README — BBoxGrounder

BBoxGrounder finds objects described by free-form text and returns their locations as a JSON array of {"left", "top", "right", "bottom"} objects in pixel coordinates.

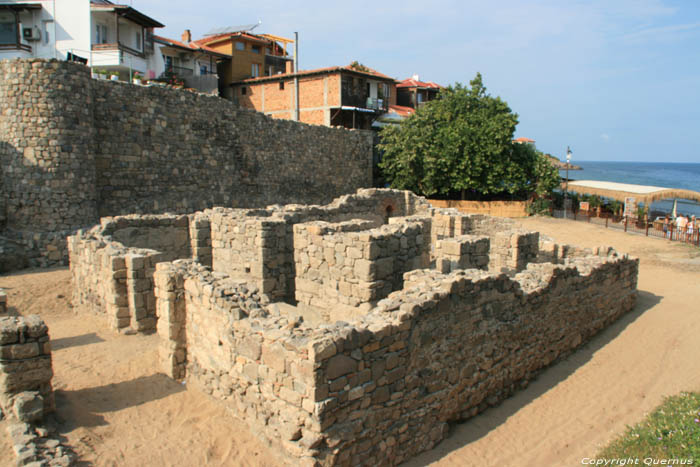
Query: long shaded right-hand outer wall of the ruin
[{"left": 304, "top": 257, "right": 638, "bottom": 465}]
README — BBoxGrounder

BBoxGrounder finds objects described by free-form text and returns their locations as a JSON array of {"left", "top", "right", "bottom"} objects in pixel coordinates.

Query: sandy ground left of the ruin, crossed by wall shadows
[{"left": 0, "top": 269, "right": 280, "bottom": 467}]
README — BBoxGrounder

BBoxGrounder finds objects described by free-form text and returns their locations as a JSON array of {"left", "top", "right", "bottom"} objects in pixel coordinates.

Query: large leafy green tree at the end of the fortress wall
[{"left": 380, "top": 73, "right": 558, "bottom": 199}]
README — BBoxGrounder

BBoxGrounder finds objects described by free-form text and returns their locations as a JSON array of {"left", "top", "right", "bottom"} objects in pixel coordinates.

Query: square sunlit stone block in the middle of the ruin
[{"left": 294, "top": 217, "right": 430, "bottom": 311}]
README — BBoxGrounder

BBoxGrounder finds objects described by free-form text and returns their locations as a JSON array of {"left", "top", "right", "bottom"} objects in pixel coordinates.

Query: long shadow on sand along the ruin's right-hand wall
[{"left": 401, "top": 290, "right": 663, "bottom": 467}]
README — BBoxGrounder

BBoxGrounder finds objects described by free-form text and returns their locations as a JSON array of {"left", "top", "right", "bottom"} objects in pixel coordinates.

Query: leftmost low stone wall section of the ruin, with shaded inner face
[{"left": 68, "top": 215, "right": 191, "bottom": 332}]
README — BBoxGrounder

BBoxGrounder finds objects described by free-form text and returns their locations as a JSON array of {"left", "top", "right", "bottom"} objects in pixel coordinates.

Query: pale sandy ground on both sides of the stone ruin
[{"left": 0, "top": 218, "right": 700, "bottom": 466}]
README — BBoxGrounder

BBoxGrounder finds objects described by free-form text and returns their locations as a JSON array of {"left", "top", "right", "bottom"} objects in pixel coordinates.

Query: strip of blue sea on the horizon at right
[{"left": 559, "top": 161, "right": 700, "bottom": 217}]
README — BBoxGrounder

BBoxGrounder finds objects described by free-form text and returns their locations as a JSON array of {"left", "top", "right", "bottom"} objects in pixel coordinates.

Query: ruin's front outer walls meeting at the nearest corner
[{"left": 155, "top": 241, "right": 638, "bottom": 465}]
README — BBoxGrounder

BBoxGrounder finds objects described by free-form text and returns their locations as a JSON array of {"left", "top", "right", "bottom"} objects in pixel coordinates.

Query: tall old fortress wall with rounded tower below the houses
[{"left": 0, "top": 59, "right": 372, "bottom": 264}]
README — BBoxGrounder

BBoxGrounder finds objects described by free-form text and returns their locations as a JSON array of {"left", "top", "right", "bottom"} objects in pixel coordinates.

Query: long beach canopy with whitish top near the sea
[{"left": 561, "top": 180, "right": 700, "bottom": 204}]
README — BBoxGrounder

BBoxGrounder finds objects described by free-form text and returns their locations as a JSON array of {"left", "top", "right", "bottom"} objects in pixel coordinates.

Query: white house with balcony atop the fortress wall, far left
[{"left": 0, "top": 0, "right": 163, "bottom": 75}]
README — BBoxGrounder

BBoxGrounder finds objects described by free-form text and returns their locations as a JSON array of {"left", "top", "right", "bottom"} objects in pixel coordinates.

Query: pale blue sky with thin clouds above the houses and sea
[{"left": 133, "top": 0, "right": 700, "bottom": 163}]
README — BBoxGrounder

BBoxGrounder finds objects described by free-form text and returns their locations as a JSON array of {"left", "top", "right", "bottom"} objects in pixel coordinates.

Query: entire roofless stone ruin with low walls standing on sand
[{"left": 69, "top": 189, "right": 638, "bottom": 465}]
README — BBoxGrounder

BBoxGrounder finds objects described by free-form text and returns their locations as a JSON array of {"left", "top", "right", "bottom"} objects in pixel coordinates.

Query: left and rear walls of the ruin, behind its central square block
[{"left": 67, "top": 189, "right": 429, "bottom": 332}]
